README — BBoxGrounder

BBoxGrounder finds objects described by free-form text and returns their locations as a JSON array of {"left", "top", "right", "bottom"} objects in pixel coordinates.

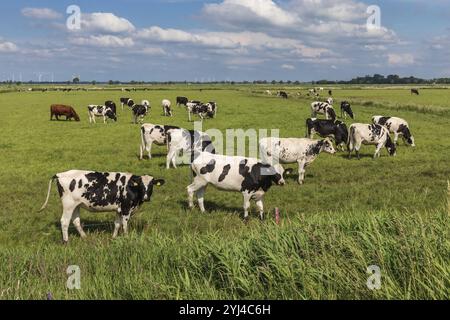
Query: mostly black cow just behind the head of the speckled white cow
[{"left": 306, "top": 118, "right": 348, "bottom": 150}]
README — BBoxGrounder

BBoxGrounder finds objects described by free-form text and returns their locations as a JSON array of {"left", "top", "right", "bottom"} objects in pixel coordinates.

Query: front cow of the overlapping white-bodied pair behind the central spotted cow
[{"left": 166, "top": 129, "right": 216, "bottom": 169}]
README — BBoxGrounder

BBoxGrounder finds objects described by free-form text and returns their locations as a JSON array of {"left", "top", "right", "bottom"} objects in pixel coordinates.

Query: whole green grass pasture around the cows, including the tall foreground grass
[{"left": 0, "top": 86, "right": 450, "bottom": 299}]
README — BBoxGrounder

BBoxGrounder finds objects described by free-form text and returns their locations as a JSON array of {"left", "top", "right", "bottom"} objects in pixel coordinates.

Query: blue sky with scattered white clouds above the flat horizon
[{"left": 0, "top": 0, "right": 450, "bottom": 81}]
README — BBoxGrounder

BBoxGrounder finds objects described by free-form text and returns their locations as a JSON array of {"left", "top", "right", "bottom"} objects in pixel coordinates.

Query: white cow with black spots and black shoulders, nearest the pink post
[{"left": 187, "top": 152, "right": 285, "bottom": 220}]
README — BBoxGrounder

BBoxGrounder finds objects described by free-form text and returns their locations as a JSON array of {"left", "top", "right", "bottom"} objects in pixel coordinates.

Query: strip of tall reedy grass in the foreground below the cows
[{"left": 0, "top": 207, "right": 450, "bottom": 299}]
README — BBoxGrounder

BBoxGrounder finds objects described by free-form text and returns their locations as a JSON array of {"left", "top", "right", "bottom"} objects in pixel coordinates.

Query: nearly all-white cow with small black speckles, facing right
[{"left": 259, "top": 138, "right": 336, "bottom": 184}]
